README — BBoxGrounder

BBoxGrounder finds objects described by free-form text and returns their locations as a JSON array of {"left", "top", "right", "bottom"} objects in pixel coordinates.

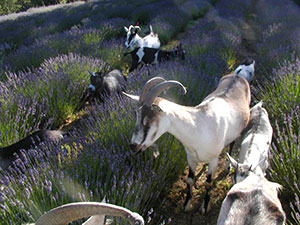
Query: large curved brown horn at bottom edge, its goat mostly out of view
[{"left": 35, "top": 202, "right": 144, "bottom": 225}]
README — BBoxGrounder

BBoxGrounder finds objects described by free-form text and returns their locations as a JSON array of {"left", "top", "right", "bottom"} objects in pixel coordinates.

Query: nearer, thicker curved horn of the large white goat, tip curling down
[{"left": 144, "top": 80, "right": 186, "bottom": 106}]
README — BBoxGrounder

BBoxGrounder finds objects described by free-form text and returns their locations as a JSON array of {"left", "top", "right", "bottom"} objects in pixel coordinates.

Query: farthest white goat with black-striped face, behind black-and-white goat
[{"left": 124, "top": 25, "right": 160, "bottom": 50}]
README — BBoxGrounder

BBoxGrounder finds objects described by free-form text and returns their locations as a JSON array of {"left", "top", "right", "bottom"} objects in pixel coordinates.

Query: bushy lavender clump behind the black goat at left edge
[{"left": 0, "top": 54, "right": 107, "bottom": 145}]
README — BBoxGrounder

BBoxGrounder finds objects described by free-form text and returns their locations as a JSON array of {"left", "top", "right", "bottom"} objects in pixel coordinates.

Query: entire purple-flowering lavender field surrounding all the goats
[{"left": 0, "top": 0, "right": 300, "bottom": 225}]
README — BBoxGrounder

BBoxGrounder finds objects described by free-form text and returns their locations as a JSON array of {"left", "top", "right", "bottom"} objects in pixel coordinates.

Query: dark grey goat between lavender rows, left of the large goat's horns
[{"left": 89, "top": 69, "right": 127, "bottom": 102}]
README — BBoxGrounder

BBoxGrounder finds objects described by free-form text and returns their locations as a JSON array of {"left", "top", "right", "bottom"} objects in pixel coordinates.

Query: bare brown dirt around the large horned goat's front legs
[{"left": 161, "top": 153, "right": 231, "bottom": 225}]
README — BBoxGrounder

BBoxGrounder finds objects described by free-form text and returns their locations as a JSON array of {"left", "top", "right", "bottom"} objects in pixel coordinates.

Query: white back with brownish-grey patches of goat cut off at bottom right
[{"left": 217, "top": 168, "right": 286, "bottom": 225}]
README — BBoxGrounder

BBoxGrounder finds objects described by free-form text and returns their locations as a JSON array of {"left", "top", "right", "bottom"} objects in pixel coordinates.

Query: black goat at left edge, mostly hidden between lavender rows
[{"left": 0, "top": 130, "right": 64, "bottom": 170}]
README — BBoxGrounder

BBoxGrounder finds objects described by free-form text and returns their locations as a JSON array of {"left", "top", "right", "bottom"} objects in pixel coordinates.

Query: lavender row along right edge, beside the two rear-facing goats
[{"left": 254, "top": 55, "right": 300, "bottom": 224}]
